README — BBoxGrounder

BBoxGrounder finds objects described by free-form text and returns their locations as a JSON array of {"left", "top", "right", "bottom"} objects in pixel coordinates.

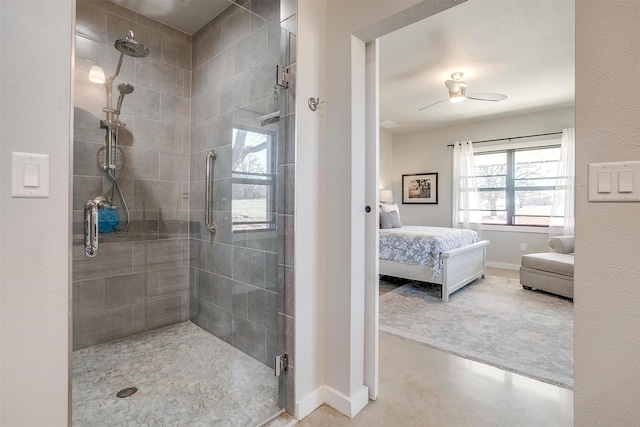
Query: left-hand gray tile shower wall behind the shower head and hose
[{"left": 73, "top": 0, "right": 192, "bottom": 349}]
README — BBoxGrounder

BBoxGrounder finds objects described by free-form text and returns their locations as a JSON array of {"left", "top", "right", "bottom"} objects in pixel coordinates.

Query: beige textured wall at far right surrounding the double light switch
[{"left": 574, "top": 1, "right": 640, "bottom": 426}]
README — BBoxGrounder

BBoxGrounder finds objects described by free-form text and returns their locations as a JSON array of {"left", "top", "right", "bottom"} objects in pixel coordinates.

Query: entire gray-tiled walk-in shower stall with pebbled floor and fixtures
[{"left": 72, "top": 0, "right": 295, "bottom": 426}]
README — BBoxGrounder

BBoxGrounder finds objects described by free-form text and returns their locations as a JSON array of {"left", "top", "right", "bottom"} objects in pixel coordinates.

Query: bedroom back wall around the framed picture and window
[{"left": 392, "top": 108, "right": 580, "bottom": 269}]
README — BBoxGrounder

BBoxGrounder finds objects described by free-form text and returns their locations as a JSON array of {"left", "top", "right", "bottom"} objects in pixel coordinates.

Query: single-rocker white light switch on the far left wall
[{"left": 11, "top": 152, "right": 49, "bottom": 197}]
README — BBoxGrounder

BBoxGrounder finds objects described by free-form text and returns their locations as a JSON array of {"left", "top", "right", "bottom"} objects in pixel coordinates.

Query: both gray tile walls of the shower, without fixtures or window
[{"left": 73, "top": 0, "right": 297, "bottom": 413}]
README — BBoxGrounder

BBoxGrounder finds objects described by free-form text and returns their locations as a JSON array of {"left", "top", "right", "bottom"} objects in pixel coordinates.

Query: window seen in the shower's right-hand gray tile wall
[{"left": 231, "top": 127, "right": 276, "bottom": 232}]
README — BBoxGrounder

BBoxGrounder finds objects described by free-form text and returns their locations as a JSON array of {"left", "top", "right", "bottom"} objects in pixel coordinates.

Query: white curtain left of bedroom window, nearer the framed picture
[{"left": 452, "top": 141, "right": 480, "bottom": 229}]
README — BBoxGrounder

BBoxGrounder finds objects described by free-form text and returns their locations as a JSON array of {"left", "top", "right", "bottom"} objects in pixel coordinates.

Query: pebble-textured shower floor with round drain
[{"left": 73, "top": 322, "right": 280, "bottom": 427}]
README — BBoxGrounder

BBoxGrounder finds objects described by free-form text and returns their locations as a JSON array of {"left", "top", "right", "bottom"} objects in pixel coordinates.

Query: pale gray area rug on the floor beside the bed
[{"left": 380, "top": 276, "right": 573, "bottom": 389}]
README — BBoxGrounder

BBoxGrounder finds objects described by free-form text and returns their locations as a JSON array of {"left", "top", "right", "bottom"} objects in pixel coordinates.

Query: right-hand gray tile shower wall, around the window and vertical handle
[{"left": 185, "top": 1, "right": 296, "bottom": 413}]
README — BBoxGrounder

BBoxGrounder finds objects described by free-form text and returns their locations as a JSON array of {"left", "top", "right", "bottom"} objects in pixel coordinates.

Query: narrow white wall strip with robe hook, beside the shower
[{"left": 294, "top": 0, "right": 327, "bottom": 417}]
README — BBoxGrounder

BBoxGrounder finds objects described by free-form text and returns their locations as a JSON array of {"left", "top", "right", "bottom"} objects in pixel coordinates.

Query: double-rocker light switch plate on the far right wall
[{"left": 589, "top": 161, "right": 640, "bottom": 202}]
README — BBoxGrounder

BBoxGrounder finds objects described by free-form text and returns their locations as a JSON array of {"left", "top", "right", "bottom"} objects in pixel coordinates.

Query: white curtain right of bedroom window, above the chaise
[{"left": 549, "top": 128, "right": 576, "bottom": 237}]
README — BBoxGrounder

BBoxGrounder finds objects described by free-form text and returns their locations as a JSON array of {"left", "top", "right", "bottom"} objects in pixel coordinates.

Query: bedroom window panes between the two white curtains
[{"left": 474, "top": 145, "right": 560, "bottom": 226}]
